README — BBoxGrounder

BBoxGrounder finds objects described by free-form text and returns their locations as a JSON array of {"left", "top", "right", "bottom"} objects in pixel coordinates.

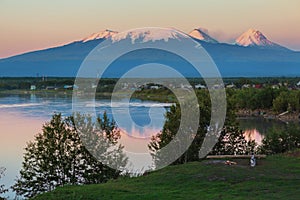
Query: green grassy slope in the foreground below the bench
[{"left": 34, "top": 152, "right": 300, "bottom": 200}]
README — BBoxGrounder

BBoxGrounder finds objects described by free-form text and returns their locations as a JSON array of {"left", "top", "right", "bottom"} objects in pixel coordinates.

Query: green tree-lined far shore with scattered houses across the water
[{"left": 0, "top": 77, "right": 300, "bottom": 123}]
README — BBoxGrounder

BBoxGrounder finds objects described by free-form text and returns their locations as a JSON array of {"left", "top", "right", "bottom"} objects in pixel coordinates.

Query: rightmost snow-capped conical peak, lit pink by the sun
[{"left": 235, "top": 28, "right": 284, "bottom": 48}]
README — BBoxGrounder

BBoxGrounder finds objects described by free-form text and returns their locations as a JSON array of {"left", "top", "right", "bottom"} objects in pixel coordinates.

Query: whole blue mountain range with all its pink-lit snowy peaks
[{"left": 0, "top": 28, "right": 300, "bottom": 77}]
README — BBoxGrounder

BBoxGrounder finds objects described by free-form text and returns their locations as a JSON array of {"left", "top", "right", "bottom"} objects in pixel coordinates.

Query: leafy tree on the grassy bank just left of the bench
[{"left": 148, "top": 90, "right": 256, "bottom": 164}]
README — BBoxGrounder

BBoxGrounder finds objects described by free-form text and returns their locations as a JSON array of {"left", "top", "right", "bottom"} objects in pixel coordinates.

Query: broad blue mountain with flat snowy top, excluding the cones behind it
[{"left": 0, "top": 29, "right": 300, "bottom": 77}]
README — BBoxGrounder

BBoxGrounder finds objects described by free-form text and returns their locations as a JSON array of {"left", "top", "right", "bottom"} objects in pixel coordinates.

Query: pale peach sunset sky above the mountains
[{"left": 0, "top": 0, "right": 300, "bottom": 58}]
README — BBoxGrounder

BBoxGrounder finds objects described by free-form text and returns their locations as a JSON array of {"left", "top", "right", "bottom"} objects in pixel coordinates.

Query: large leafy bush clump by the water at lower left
[{"left": 12, "top": 113, "right": 127, "bottom": 198}]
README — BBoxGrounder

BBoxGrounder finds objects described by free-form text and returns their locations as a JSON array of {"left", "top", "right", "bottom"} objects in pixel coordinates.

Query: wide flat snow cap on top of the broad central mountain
[{"left": 111, "top": 28, "right": 188, "bottom": 43}]
